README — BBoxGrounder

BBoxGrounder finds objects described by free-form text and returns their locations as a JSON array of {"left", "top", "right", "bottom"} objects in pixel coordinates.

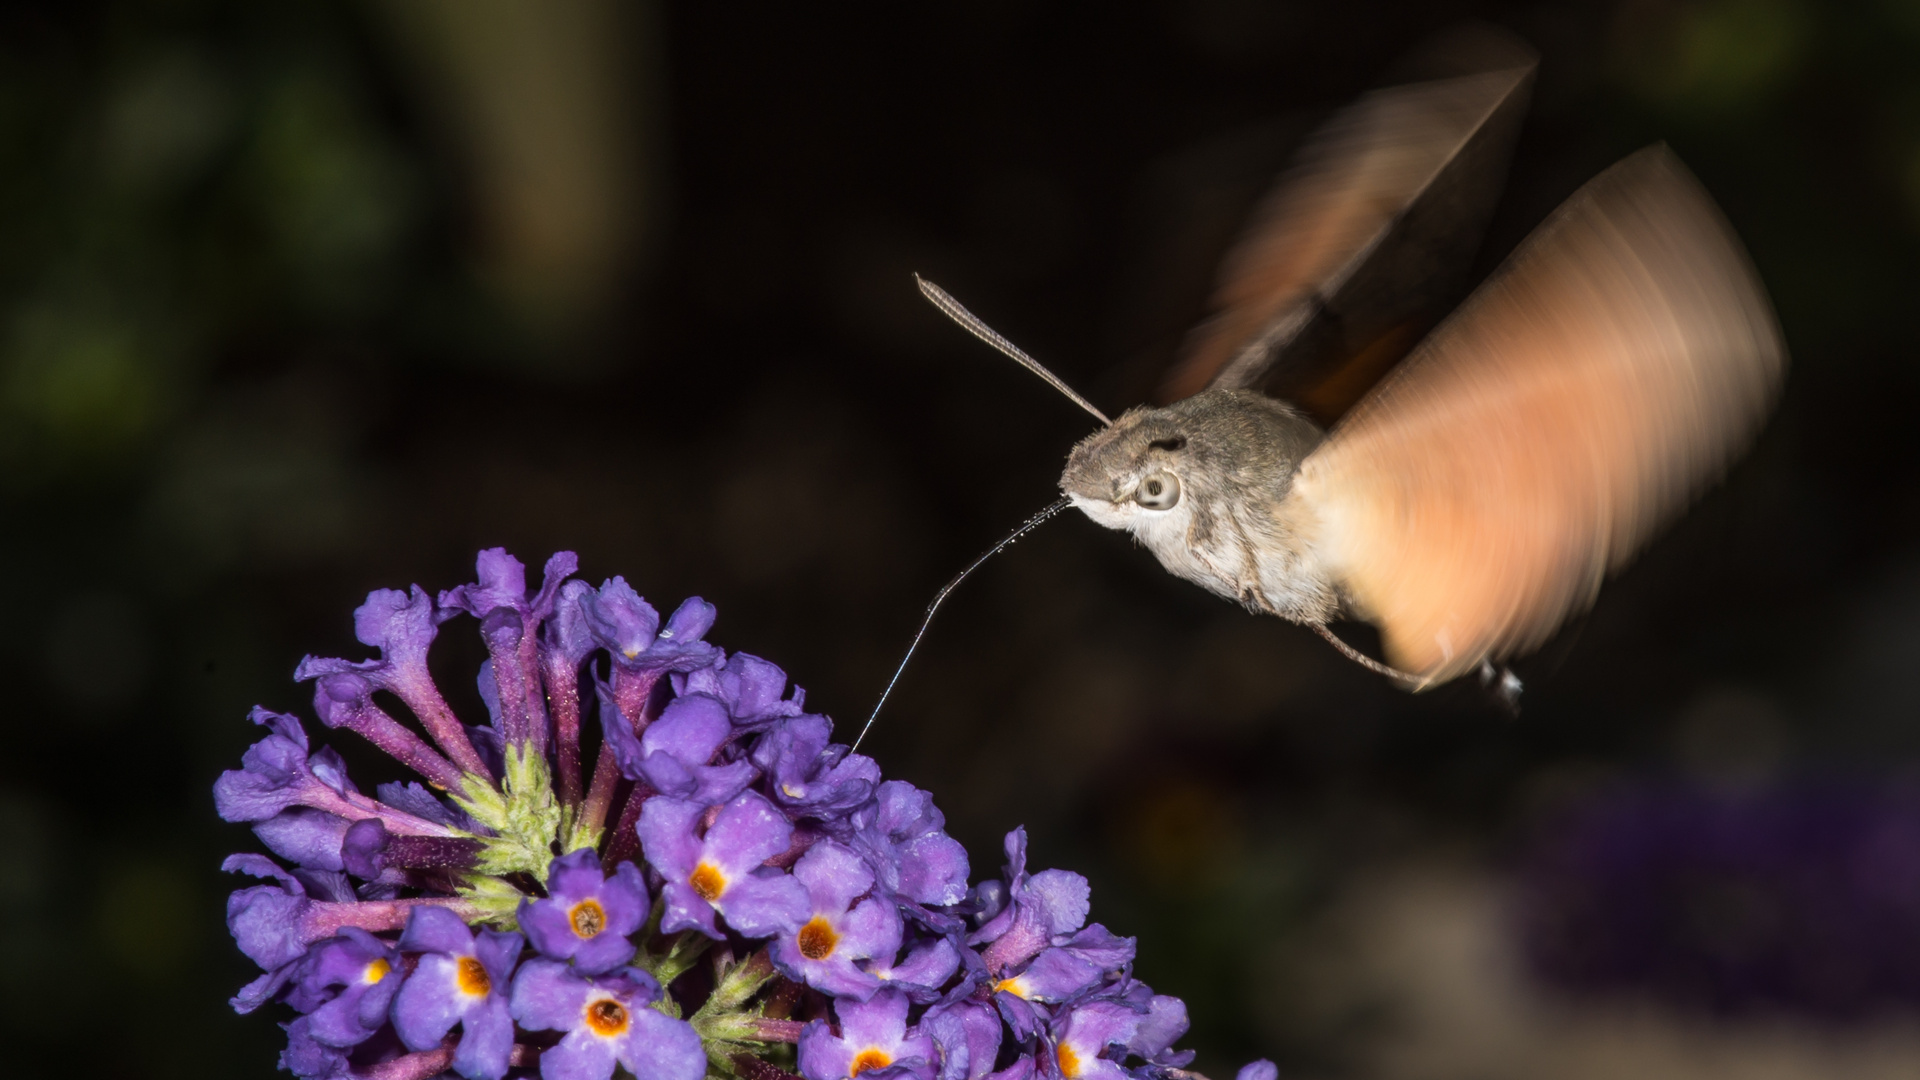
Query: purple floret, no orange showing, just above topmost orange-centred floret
[{"left": 601, "top": 694, "right": 758, "bottom": 805}]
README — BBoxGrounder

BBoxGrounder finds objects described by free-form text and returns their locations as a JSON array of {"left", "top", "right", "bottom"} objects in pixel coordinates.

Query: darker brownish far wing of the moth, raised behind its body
[{"left": 1158, "top": 38, "right": 1534, "bottom": 421}]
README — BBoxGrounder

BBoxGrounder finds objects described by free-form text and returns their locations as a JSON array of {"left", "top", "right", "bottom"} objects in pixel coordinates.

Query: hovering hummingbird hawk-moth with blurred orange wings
[{"left": 864, "top": 27, "right": 1786, "bottom": 737}]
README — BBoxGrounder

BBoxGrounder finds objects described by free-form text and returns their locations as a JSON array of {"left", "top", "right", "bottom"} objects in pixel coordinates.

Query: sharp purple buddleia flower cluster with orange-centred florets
[{"left": 215, "top": 550, "right": 1273, "bottom": 1080}]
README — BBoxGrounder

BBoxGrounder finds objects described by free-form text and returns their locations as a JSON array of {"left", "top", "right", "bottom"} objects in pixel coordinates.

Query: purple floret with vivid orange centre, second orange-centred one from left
[{"left": 394, "top": 907, "right": 520, "bottom": 1080}]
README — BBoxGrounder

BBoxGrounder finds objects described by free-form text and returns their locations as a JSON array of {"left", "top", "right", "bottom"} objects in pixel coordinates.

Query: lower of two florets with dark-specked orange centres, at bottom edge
[{"left": 513, "top": 959, "right": 707, "bottom": 1080}]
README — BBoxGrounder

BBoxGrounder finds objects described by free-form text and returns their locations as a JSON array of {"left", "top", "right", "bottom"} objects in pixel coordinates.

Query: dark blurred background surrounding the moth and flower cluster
[{"left": 0, "top": 0, "right": 1920, "bottom": 1080}]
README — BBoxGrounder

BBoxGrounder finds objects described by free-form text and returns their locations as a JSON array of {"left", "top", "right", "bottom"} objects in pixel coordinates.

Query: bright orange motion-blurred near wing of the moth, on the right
[{"left": 1294, "top": 146, "right": 1786, "bottom": 682}]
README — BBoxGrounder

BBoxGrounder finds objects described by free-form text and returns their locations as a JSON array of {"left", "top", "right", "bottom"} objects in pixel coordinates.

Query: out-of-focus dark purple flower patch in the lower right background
[{"left": 1515, "top": 776, "right": 1920, "bottom": 1019}]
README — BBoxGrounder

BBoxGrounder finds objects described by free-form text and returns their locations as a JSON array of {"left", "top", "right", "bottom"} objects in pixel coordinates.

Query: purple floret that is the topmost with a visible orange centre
[{"left": 639, "top": 792, "right": 810, "bottom": 938}]
